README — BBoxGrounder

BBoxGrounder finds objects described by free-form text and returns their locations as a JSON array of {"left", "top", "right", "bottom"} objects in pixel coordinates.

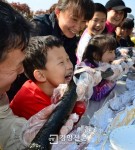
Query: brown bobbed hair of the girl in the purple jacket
[{"left": 82, "top": 34, "right": 116, "bottom": 61}]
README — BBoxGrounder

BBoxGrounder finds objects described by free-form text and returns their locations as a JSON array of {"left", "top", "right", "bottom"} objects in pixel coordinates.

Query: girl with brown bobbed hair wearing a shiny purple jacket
[{"left": 82, "top": 35, "right": 116, "bottom": 101}]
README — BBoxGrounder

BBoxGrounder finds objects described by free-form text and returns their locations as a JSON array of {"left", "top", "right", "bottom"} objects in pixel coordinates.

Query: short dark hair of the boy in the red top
[{"left": 23, "top": 35, "right": 63, "bottom": 81}]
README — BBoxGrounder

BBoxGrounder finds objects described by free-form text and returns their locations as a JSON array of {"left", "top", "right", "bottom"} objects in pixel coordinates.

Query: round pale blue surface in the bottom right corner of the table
[{"left": 109, "top": 125, "right": 135, "bottom": 150}]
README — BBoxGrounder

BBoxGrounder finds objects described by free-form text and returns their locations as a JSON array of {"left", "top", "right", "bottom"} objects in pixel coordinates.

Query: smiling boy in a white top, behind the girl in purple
[{"left": 76, "top": 3, "right": 107, "bottom": 63}]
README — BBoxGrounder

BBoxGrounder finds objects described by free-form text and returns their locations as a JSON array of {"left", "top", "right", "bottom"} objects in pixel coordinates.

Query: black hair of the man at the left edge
[{"left": 0, "top": 1, "right": 31, "bottom": 62}]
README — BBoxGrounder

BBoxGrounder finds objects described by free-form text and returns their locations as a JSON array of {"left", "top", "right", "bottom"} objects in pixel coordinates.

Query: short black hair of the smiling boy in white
[{"left": 94, "top": 3, "right": 107, "bottom": 18}]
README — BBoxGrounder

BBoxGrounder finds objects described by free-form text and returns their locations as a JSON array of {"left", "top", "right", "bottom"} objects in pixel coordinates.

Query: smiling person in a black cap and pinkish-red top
[{"left": 104, "top": 0, "right": 131, "bottom": 33}]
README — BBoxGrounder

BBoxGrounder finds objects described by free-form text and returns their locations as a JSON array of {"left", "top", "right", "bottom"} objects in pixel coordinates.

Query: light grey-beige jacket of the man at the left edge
[{"left": 0, "top": 94, "right": 27, "bottom": 150}]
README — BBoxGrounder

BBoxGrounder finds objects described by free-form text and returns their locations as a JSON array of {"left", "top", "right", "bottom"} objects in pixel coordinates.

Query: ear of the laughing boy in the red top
[{"left": 33, "top": 70, "right": 46, "bottom": 82}]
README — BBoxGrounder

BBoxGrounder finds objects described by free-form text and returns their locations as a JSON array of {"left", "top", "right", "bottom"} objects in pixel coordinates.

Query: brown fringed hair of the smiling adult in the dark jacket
[{"left": 56, "top": 0, "right": 94, "bottom": 20}]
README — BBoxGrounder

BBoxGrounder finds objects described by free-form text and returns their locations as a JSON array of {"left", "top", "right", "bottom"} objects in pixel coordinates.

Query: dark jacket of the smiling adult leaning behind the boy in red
[{"left": 32, "top": 13, "right": 79, "bottom": 66}]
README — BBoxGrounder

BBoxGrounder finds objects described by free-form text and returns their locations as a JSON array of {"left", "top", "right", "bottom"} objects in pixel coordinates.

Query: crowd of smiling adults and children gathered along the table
[{"left": 0, "top": 0, "right": 135, "bottom": 150}]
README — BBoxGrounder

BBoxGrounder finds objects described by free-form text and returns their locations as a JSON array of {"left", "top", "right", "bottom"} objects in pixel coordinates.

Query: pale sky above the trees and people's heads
[{"left": 7, "top": 0, "right": 135, "bottom": 17}]
